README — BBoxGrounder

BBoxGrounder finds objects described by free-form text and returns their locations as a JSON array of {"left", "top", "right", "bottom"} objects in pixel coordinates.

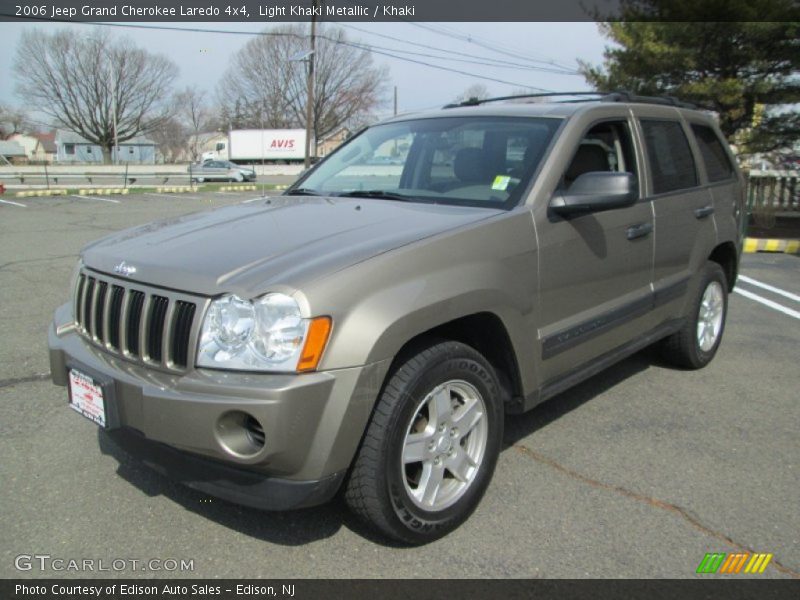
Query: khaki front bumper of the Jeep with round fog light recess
[{"left": 48, "top": 304, "right": 389, "bottom": 510}]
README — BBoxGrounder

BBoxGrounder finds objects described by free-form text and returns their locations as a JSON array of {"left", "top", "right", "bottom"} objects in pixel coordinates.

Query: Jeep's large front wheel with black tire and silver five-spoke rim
[{"left": 345, "top": 342, "right": 503, "bottom": 544}]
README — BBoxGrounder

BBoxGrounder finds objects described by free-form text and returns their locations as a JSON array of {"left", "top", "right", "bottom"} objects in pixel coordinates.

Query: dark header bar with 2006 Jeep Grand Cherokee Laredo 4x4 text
[{"left": 6, "top": 0, "right": 800, "bottom": 22}]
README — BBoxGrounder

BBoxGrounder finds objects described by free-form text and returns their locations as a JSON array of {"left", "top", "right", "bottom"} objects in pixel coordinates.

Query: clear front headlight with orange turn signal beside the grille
[{"left": 197, "top": 294, "right": 330, "bottom": 372}]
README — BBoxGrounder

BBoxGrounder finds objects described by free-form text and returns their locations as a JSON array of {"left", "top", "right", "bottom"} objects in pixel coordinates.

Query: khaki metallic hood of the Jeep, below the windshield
[{"left": 82, "top": 196, "right": 494, "bottom": 297}]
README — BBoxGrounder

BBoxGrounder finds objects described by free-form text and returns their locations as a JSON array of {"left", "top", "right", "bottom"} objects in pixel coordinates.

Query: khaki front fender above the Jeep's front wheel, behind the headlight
[{"left": 302, "top": 209, "right": 537, "bottom": 396}]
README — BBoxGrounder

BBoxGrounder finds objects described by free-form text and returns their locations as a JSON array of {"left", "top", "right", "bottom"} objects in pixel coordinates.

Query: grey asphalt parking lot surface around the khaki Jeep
[{"left": 0, "top": 192, "right": 800, "bottom": 578}]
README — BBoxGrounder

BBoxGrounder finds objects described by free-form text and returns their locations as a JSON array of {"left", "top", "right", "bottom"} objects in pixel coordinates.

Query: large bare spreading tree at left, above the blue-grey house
[{"left": 14, "top": 30, "right": 178, "bottom": 163}]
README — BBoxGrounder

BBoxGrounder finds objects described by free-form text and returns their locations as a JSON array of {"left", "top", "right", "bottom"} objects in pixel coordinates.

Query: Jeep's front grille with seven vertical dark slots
[{"left": 74, "top": 269, "right": 205, "bottom": 371}]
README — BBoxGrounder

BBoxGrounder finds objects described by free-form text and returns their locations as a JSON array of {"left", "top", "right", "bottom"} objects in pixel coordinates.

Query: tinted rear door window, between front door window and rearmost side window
[{"left": 641, "top": 119, "right": 698, "bottom": 194}]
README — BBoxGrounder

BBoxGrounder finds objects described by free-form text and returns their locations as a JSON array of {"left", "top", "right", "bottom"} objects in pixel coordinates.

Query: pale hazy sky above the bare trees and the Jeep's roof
[{"left": 0, "top": 22, "right": 607, "bottom": 123}]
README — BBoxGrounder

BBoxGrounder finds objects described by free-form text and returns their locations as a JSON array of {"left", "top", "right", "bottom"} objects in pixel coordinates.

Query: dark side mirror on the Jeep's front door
[{"left": 550, "top": 171, "right": 639, "bottom": 217}]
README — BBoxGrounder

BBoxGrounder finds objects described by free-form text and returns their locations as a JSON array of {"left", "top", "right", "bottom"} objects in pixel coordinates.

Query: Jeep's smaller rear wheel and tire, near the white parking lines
[{"left": 662, "top": 261, "right": 728, "bottom": 369}]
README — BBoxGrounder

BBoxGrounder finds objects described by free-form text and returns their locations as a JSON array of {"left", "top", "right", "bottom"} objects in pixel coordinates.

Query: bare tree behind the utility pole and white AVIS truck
[{"left": 217, "top": 24, "right": 386, "bottom": 145}]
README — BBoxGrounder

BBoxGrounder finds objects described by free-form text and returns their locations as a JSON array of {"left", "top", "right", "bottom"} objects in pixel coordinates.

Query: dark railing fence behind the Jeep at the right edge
[{"left": 747, "top": 171, "right": 800, "bottom": 228}]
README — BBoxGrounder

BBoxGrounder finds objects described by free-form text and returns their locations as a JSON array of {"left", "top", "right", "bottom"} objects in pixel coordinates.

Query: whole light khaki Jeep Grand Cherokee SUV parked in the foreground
[{"left": 49, "top": 95, "right": 743, "bottom": 543}]
